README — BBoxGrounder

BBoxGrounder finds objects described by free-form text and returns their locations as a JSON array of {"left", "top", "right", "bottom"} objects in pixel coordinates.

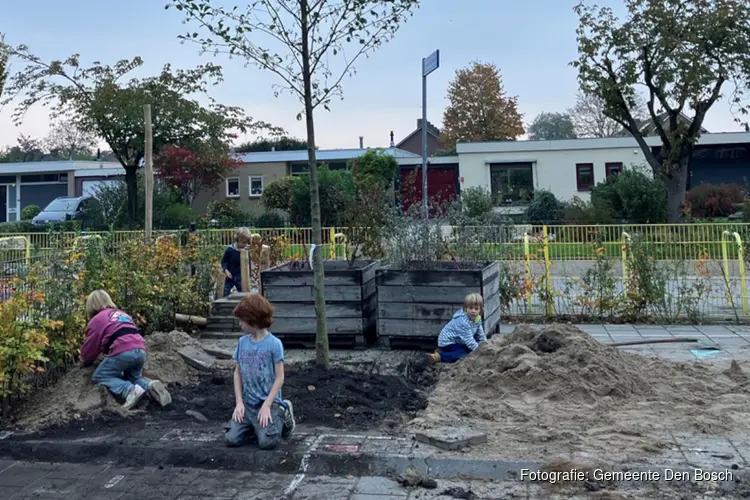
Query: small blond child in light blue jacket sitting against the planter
[{"left": 427, "top": 293, "right": 487, "bottom": 363}]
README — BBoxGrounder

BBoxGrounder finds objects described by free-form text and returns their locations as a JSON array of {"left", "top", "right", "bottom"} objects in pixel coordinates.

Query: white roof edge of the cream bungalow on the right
[{"left": 456, "top": 132, "right": 750, "bottom": 154}]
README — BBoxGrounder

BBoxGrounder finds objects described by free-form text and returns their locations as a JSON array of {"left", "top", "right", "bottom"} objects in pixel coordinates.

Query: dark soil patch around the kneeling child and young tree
[{"left": 27, "top": 358, "right": 439, "bottom": 435}]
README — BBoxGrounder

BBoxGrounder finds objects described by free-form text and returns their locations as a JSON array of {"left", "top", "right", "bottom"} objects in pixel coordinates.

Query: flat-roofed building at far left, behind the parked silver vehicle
[{"left": 0, "top": 161, "right": 125, "bottom": 222}]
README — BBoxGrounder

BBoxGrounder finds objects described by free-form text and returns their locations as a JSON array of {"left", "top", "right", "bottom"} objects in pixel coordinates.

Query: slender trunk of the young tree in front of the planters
[{"left": 300, "top": 0, "right": 330, "bottom": 370}]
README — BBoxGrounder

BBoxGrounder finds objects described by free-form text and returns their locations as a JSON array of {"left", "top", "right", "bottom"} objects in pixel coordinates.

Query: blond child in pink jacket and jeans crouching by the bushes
[{"left": 81, "top": 290, "right": 172, "bottom": 410}]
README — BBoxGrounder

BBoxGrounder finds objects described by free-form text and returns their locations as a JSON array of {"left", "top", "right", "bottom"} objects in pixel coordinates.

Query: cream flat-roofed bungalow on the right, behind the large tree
[{"left": 456, "top": 132, "right": 750, "bottom": 213}]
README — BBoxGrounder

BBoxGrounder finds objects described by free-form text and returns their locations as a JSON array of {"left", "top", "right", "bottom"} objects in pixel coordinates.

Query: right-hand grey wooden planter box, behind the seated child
[{"left": 376, "top": 262, "right": 500, "bottom": 348}]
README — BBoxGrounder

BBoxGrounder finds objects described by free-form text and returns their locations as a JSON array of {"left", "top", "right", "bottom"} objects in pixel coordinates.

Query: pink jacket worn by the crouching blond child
[{"left": 81, "top": 309, "right": 146, "bottom": 366}]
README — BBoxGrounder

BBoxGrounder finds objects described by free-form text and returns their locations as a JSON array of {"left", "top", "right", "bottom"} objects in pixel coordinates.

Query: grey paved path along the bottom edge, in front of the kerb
[{"left": 0, "top": 461, "right": 745, "bottom": 500}]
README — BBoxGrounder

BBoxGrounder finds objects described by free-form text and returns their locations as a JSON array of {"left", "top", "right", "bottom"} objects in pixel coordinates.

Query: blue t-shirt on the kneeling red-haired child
[{"left": 232, "top": 332, "right": 284, "bottom": 407}]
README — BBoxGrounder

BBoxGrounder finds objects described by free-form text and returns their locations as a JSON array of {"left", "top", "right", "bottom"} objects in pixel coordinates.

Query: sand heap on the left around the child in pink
[{"left": 16, "top": 330, "right": 220, "bottom": 432}]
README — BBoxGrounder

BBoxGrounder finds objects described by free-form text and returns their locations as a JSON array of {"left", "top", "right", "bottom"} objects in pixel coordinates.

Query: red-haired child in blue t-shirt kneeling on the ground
[{"left": 225, "top": 293, "right": 295, "bottom": 450}]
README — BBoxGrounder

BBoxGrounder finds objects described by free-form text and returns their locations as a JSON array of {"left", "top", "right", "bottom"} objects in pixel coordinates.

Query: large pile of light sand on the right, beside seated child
[{"left": 412, "top": 325, "right": 750, "bottom": 459}]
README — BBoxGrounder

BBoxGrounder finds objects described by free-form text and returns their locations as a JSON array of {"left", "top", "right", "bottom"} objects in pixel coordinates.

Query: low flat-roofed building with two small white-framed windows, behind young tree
[{"left": 193, "top": 147, "right": 421, "bottom": 213}]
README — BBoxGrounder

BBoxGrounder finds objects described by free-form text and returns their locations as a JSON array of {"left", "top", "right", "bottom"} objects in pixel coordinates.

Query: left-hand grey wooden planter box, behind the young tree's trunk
[{"left": 260, "top": 260, "right": 377, "bottom": 348}]
